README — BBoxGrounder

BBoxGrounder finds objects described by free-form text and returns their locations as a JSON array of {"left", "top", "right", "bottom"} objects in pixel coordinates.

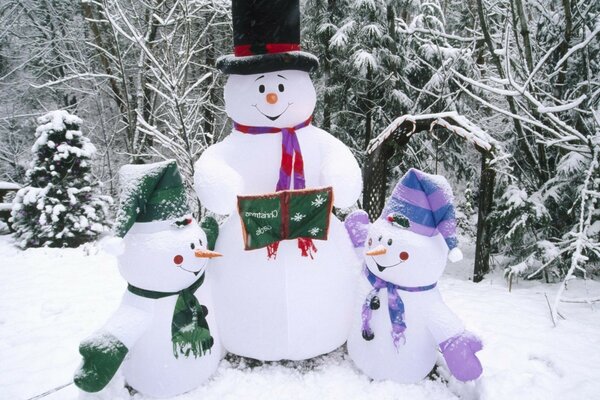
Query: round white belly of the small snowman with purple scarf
[{"left": 348, "top": 282, "right": 437, "bottom": 383}]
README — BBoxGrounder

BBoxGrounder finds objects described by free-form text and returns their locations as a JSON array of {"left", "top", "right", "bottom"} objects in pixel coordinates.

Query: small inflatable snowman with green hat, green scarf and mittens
[{"left": 74, "top": 161, "right": 223, "bottom": 397}]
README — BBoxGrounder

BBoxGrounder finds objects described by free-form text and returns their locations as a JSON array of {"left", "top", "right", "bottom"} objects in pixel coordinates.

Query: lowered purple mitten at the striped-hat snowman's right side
[{"left": 440, "top": 331, "right": 483, "bottom": 382}]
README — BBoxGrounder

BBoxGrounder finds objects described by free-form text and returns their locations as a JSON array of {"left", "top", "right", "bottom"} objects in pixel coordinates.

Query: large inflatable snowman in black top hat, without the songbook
[{"left": 195, "top": 0, "right": 362, "bottom": 360}]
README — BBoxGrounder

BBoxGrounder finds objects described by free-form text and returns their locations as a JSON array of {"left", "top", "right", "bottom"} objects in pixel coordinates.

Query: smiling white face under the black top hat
[{"left": 225, "top": 70, "right": 317, "bottom": 128}]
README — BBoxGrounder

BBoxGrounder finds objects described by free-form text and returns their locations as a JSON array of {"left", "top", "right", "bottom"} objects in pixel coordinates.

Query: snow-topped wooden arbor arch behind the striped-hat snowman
[{"left": 363, "top": 111, "right": 501, "bottom": 282}]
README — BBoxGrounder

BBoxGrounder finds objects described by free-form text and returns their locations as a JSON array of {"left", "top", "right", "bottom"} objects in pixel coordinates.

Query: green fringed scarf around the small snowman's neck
[{"left": 127, "top": 274, "right": 214, "bottom": 358}]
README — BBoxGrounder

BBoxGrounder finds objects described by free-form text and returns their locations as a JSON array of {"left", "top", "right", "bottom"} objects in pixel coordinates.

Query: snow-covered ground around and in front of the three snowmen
[{"left": 0, "top": 236, "right": 600, "bottom": 400}]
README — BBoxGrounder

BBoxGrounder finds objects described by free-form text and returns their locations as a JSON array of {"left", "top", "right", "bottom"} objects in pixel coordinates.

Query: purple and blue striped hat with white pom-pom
[{"left": 379, "top": 168, "right": 462, "bottom": 261}]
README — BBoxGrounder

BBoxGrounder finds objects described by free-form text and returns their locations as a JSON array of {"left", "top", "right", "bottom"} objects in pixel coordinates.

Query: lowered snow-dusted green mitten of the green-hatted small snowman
[{"left": 73, "top": 332, "right": 129, "bottom": 393}]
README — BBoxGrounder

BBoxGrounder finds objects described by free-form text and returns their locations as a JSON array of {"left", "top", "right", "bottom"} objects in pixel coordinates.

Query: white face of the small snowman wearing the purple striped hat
[{"left": 365, "top": 219, "right": 448, "bottom": 287}]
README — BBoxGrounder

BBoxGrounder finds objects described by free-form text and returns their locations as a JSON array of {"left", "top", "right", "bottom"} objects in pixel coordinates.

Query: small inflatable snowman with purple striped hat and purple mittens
[{"left": 345, "top": 169, "right": 482, "bottom": 383}]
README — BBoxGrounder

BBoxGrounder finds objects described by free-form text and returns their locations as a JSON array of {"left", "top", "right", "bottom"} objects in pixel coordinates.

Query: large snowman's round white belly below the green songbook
[{"left": 209, "top": 216, "right": 359, "bottom": 360}]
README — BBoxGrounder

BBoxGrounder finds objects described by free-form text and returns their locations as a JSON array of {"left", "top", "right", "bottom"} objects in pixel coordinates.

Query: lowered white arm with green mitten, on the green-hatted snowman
[{"left": 73, "top": 304, "right": 151, "bottom": 393}]
